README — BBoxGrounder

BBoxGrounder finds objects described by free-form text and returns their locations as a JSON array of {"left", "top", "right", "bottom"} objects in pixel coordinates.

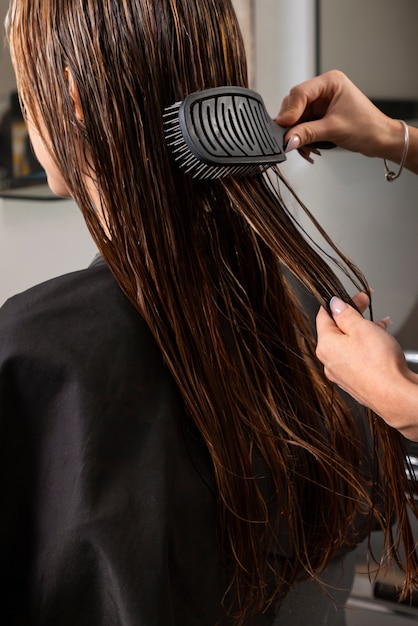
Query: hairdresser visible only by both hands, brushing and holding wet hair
[{"left": 277, "top": 71, "right": 418, "bottom": 441}]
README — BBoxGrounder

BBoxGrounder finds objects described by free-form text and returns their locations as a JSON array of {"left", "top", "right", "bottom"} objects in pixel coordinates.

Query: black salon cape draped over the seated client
[{"left": 0, "top": 256, "right": 353, "bottom": 626}]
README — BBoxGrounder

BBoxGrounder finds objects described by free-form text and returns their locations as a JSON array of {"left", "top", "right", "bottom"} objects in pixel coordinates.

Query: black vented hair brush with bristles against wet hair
[{"left": 163, "top": 87, "right": 334, "bottom": 179}]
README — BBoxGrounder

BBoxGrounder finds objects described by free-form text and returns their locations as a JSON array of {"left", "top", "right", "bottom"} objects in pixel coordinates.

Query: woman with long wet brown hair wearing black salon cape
[{"left": 0, "top": 6, "right": 418, "bottom": 626}]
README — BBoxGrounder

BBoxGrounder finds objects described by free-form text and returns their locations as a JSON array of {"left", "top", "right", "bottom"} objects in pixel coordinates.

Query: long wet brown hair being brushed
[{"left": 9, "top": 0, "right": 418, "bottom": 623}]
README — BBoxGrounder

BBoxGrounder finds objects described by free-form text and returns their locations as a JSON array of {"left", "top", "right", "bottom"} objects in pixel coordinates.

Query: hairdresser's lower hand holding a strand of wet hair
[{"left": 317, "top": 293, "right": 418, "bottom": 440}]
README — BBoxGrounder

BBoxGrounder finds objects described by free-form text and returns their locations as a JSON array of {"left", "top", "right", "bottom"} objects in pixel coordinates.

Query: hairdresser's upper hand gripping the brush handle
[{"left": 276, "top": 70, "right": 404, "bottom": 162}]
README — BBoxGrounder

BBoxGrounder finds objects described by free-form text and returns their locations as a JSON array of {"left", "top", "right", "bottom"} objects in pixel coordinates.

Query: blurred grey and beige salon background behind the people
[{"left": 0, "top": 0, "right": 418, "bottom": 626}]
